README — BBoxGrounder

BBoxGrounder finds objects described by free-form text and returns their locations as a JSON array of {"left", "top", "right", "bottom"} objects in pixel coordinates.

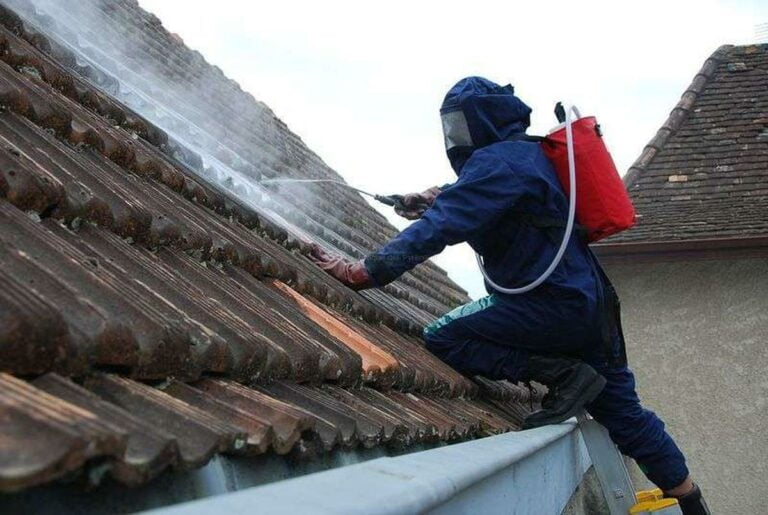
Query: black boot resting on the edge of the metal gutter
[{"left": 523, "top": 356, "right": 605, "bottom": 429}]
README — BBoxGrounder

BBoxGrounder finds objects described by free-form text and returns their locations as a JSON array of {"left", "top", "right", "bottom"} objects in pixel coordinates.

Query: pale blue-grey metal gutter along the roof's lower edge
[{"left": 146, "top": 422, "right": 590, "bottom": 515}]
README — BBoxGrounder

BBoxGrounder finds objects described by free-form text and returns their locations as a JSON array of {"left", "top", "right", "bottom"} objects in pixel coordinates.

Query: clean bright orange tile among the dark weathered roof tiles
[{"left": 272, "top": 280, "right": 400, "bottom": 378}]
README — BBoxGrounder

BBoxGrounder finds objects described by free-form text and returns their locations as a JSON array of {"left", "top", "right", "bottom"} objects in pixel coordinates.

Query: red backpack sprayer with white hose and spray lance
[{"left": 261, "top": 103, "right": 635, "bottom": 294}]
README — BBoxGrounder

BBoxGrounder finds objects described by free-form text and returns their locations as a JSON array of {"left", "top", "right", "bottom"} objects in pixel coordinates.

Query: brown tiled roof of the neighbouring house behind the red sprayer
[{"left": 603, "top": 45, "right": 768, "bottom": 246}]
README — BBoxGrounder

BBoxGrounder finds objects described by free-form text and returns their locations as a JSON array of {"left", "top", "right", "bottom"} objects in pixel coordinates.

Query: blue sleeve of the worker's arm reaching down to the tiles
[{"left": 364, "top": 150, "right": 521, "bottom": 286}]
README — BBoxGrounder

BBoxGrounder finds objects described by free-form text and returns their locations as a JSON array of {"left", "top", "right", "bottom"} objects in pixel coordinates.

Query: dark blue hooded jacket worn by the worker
[{"left": 365, "top": 77, "right": 601, "bottom": 332}]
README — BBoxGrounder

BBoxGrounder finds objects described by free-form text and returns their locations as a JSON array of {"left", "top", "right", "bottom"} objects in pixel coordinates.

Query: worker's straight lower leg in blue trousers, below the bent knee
[{"left": 587, "top": 362, "right": 688, "bottom": 491}]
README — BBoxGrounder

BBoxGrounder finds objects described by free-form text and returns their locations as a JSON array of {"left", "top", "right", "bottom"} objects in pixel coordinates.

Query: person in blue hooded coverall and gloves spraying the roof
[{"left": 312, "top": 77, "right": 709, "bottom": 515}]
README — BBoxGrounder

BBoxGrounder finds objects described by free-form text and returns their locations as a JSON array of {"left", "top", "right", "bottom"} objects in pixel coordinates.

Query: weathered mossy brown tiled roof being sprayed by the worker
[{"left": 0, "top": 0, "right": 529, "bottom": 491}]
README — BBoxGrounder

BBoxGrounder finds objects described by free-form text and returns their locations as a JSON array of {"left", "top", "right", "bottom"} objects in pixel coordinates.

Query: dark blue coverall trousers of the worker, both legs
[{"left": 424, "top": 295, "right": 688, "bottom": 490}]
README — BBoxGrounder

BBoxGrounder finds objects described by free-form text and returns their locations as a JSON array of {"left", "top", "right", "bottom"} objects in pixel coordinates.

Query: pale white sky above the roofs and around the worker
[{"left": 139, "top": 0, "right": 768, "bottom": 298}]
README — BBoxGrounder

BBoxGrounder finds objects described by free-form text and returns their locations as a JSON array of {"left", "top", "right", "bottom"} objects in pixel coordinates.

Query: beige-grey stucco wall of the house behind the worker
[{"left": 606, "top": 259, "right": 768, "bottom": 514}]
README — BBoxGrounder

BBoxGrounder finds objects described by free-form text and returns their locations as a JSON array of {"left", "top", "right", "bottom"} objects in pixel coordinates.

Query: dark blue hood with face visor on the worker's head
[{"left": 440, "top": 77, "right": 531, "bottom": 175}]
